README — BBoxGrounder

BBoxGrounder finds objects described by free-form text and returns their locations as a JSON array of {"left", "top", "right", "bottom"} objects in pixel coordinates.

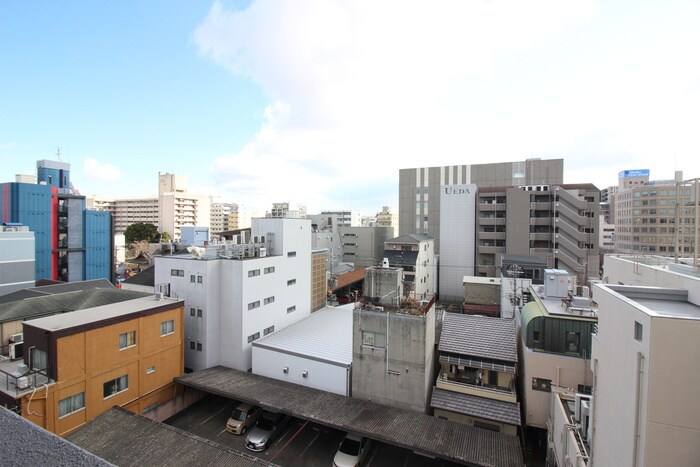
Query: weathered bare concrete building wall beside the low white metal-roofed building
[{"left": 352, "top": 309, "right": 435, "bottom": 412}]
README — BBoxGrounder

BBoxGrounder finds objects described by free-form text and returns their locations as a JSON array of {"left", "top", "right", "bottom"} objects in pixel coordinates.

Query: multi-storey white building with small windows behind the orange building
[{"left": 155, "top": 218, "right": 311, "bottom": 371}]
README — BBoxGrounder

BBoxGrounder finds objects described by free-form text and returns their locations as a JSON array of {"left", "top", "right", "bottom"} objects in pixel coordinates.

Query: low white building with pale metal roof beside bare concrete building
[{"left": 253, "top": 303, "right": 355, "bottom": 396}]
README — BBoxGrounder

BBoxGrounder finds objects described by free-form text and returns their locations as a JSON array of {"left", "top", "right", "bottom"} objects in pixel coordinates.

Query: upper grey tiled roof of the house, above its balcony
[{"left": 438, "top": 312, "right": 518, "bottom": 362}]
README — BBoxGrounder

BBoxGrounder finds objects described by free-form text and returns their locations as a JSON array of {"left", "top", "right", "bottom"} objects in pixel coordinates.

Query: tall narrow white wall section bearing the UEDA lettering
[{"left": 438, "top": 185, "right": 476, "bottom": 303}]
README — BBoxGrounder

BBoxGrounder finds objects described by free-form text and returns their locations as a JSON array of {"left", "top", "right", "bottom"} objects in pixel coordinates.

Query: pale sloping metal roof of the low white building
[{"left": 253, "top": 303, "right": 355, "bottom": 367}]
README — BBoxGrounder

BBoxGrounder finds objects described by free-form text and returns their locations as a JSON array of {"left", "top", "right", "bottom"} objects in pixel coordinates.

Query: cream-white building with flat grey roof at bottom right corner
[{"left": 588, "top": 284, "right": 700, "bottom": 466}]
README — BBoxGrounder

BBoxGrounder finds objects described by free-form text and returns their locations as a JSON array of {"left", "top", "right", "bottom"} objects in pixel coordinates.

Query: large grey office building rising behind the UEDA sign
[{"left": 399, "top": 159, "right": 564, "bottom": 253}]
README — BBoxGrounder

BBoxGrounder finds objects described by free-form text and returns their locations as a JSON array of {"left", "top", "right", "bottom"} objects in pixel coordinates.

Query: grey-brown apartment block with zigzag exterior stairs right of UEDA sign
[{"left": 476, "top": 184, "right": 600, "bottom": 284}]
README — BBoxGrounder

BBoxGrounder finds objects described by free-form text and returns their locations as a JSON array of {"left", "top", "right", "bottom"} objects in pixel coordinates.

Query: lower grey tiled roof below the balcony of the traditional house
[{"left": 430, "top": 388, "right": 520, "bottom": 426}]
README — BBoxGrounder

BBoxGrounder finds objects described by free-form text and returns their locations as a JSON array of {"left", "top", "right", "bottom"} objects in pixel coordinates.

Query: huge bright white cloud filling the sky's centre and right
[{"left": 193, "top": 0, "right": 700, "bottom": 211}]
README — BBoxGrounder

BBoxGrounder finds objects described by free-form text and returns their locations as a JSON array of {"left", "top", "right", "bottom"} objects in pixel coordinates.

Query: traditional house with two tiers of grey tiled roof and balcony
[{"left": 430, "top": 313, "right": 520, "bottom": 436}]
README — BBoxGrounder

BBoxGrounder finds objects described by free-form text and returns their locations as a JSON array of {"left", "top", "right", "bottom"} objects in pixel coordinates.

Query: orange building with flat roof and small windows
[{"left": 11, "top": 296, "right": 184, "bottom": 436}]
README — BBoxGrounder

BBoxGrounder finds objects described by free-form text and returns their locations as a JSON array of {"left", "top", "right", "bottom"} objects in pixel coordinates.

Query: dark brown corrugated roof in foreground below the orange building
[{"left": 67, "top": 407, "right": 273, "bottom": 467}]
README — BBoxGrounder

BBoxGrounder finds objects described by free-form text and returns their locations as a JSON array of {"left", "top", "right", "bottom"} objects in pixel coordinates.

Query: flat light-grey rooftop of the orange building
[{"left": 26, "top": 294, "right": 182, "bottom": 332}]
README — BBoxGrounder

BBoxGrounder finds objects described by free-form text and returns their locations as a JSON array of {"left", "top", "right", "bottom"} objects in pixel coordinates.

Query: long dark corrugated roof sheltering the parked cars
[{"left": 176, "top": 366, "right": 523, "bottom": 467}]
